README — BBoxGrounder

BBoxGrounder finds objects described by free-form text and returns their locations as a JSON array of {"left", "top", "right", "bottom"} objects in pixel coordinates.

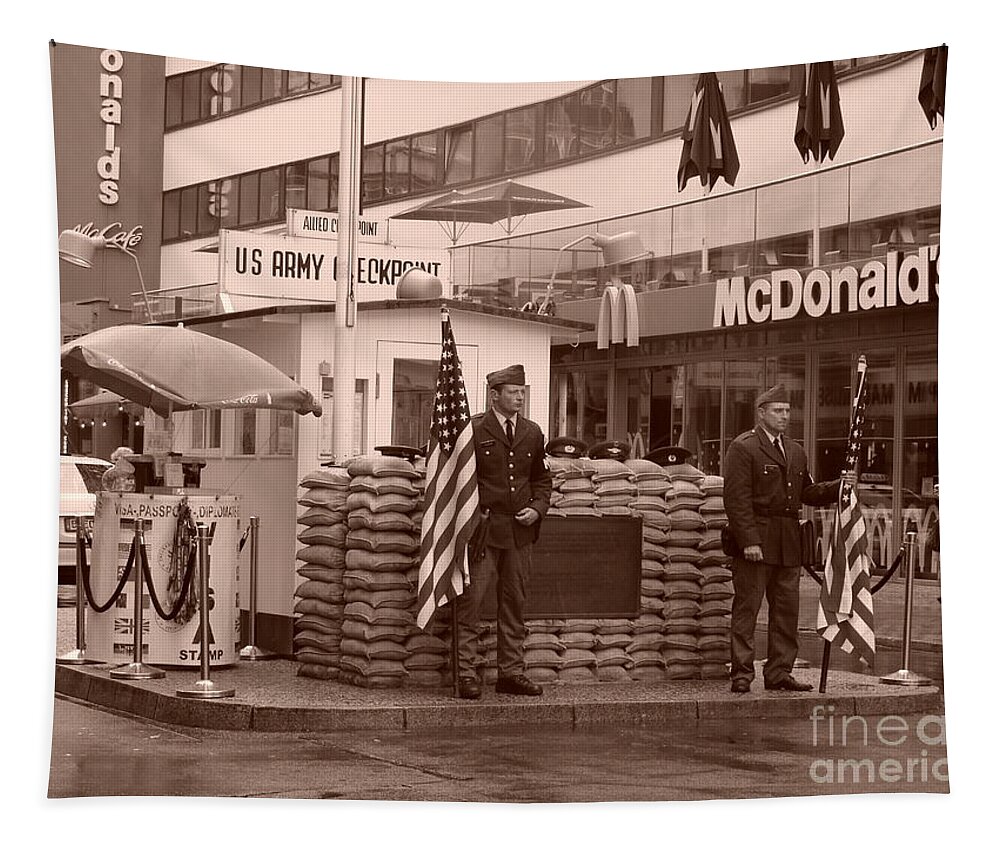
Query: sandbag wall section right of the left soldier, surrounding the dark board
[{"left": 525, "top": 458, "right": 733, "bottom": 683}]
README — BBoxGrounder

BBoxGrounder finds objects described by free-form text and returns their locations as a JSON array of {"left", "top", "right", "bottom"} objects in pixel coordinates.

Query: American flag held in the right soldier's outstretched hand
[{"left": 816, "top": 355, "right": 875, "bottom": 666}]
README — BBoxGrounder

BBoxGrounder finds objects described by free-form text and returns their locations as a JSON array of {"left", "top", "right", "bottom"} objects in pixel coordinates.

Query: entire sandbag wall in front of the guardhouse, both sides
[{"left": 294, "top": 455, "right": 733, "bottom": 687}]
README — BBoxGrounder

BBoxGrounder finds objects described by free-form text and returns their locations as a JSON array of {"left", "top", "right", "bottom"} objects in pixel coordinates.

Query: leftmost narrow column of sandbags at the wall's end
[{"left": 292, "top": 468, "right": 350, "bottom": 679}]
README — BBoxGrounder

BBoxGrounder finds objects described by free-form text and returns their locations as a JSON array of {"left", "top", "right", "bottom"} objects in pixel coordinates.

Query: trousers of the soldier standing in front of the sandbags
[{"left": 457, "top": 545, "right": 531, "bottom": 677}]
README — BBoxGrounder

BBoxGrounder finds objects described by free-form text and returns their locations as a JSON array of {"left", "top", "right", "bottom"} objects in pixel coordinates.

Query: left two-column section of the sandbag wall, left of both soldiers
[{"left": 293, "top": 455, "right": 449, "bottom": 688}]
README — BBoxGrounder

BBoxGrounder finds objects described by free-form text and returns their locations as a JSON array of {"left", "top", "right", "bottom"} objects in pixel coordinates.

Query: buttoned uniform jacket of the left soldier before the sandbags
[{"left": 472, "top": 410, "right": 552, "bottom": 549}]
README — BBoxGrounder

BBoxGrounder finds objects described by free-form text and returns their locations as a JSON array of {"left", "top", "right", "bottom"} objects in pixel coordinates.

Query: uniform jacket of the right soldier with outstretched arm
[{"left": 723, "top": 427, "right": 839, "bottom": 567}]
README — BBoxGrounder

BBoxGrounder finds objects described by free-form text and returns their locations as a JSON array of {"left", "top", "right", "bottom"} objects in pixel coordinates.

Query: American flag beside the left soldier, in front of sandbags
[{"left": 417, "top": 309, "right": 479, "bottom": 629}]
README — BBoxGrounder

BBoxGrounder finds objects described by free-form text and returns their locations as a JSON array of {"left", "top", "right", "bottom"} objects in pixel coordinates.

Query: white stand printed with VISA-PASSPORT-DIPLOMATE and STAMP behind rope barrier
[{"left": 87, "top": 491, "right": 240, "bottom": 668}]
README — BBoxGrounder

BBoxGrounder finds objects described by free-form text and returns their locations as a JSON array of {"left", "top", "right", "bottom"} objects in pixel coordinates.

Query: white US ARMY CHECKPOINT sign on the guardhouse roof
[{"left": 219, "top": 223, "right": 449, "bottom": 308}]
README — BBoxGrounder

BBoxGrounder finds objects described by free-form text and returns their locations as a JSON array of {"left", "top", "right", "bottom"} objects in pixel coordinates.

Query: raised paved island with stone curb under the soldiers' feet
[{"left": 54, "top": 608, "right": 943, "bottom": 732}]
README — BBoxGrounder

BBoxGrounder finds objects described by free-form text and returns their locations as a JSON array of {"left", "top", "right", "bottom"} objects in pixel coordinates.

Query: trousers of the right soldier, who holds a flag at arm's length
[{"left": 730, "top": 558, "right": 801, "bottom": 684}]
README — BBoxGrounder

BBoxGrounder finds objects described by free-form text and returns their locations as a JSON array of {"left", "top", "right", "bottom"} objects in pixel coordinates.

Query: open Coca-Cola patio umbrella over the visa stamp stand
[{"left": 60, "top": 325, "right": 322, "bottom": 417}]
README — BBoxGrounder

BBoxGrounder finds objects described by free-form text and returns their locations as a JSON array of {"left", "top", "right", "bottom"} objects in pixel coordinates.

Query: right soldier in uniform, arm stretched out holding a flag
[{"left": 723, "top": 384, "right": 857, "bottom": 694}]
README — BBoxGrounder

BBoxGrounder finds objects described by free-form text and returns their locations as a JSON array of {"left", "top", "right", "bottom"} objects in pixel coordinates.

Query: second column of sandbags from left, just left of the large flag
[{"left": 341, "top": 455, "right": 422, "bottom": 688}]
